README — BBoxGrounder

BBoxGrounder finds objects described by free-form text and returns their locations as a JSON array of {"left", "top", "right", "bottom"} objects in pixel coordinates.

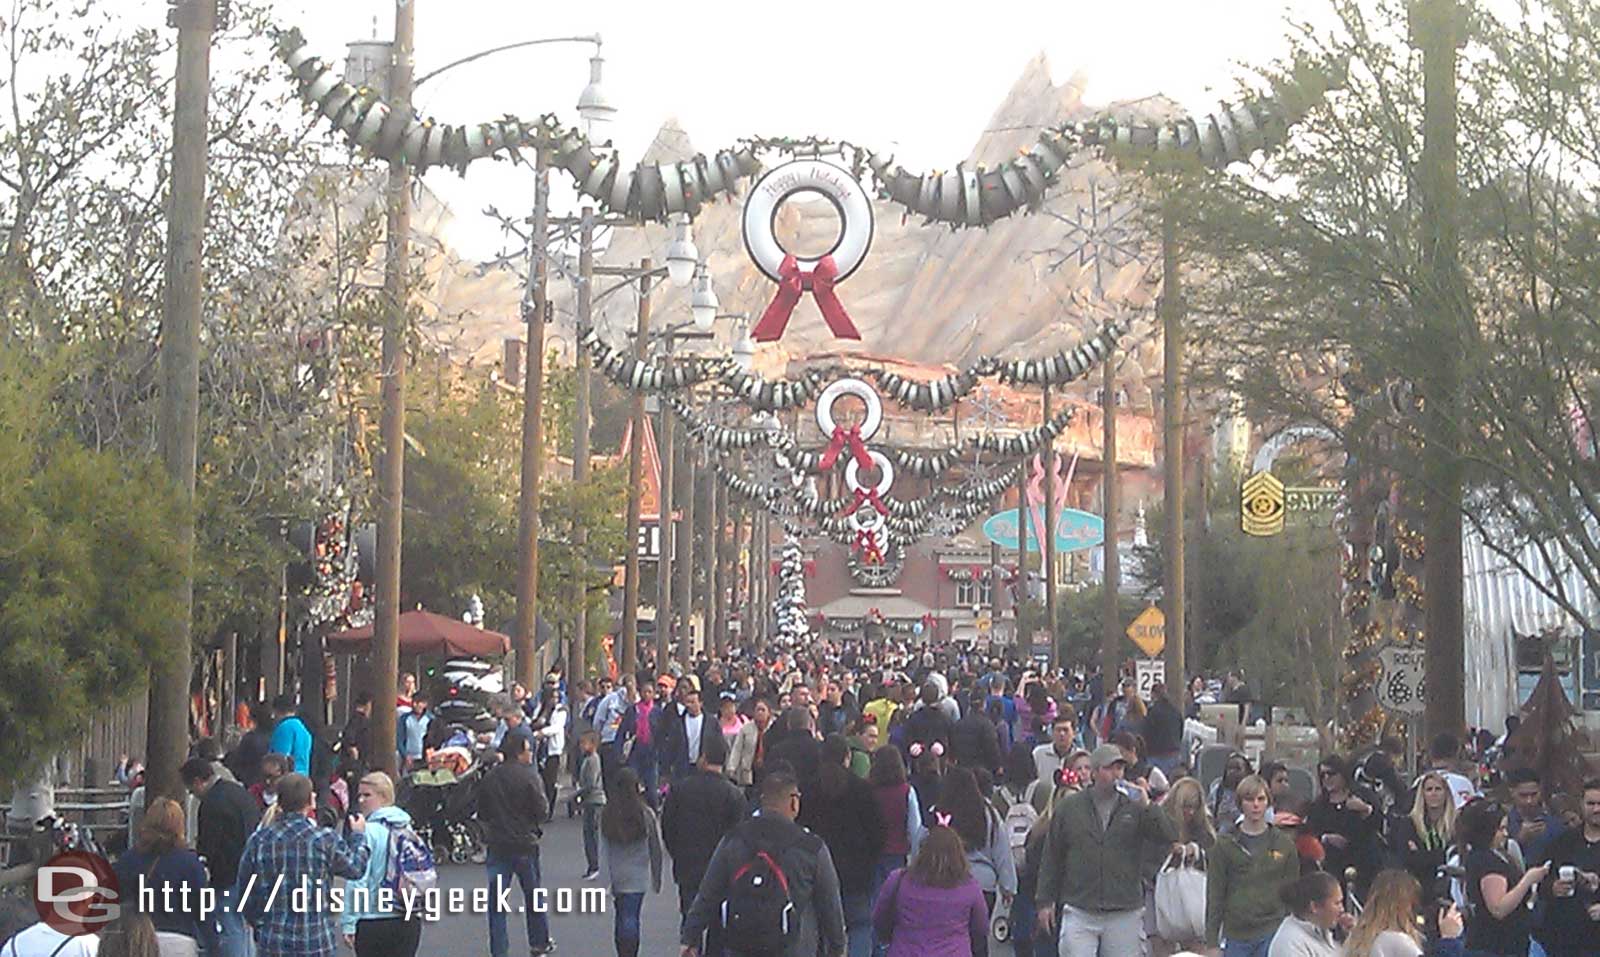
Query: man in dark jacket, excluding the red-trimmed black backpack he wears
[{"left": 678, "top": 768, "right": 845, "bottom": 957}]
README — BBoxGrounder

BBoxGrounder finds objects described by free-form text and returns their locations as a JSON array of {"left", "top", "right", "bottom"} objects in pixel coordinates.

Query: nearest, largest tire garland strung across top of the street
[{"left": 277, "top": 29, "right": 1346, "bottom": 227}]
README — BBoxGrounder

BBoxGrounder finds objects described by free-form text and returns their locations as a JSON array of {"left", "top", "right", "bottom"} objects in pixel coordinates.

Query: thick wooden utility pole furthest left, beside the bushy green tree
[{"left": 146, "top": 0, "right": 216, "bottom": 800}]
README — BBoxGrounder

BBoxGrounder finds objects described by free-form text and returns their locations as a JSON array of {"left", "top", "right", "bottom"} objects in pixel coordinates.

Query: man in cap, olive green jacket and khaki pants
[{"left": 1035, "top": 744, "right": 1178, "bottom": 957}]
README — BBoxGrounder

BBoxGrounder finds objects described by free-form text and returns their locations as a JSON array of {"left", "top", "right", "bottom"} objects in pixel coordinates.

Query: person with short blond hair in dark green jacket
[{"left": 1205, "top": 775, "right": 1299, "bottom": 957}]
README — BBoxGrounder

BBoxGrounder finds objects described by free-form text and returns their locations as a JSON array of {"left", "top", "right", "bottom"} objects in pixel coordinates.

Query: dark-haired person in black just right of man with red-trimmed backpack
[{"left": 798, "top": 735, "right": 888, "bottom": 954}]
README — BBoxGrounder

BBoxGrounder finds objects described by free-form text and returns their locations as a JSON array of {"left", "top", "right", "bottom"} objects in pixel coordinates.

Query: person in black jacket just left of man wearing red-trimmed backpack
[{"left": 661, "top": 735, "right": 746, "bottom": 954}]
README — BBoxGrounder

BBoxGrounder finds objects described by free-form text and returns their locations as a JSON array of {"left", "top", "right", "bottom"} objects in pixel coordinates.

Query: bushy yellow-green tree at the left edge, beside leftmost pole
[{"left": 0, "top": 350, "right": 179, "bottom": 779}]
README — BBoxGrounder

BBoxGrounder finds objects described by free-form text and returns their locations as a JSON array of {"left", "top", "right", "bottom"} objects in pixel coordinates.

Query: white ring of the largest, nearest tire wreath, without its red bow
[{"left": 744, "top": 160, "right": 872, "bottom": 283}]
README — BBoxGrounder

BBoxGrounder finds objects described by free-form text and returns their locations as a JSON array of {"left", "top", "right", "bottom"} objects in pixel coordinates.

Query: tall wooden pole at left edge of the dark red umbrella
[{"left": 371, "top": 0, "right": 416, "bottom": 776}]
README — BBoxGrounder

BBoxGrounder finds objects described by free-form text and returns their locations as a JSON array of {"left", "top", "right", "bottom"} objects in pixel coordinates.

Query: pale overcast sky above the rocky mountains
[{"left": 203, "top": 0, "right": 1326, "bottom": 256}]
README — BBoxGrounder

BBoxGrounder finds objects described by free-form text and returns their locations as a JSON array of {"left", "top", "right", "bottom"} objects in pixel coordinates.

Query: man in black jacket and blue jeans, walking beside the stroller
[{"left": 478, "top": 736, "right": 555, "bottom": 957}]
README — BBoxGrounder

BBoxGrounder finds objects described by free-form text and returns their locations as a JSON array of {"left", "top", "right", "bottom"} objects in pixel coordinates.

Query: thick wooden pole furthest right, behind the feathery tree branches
[{"left": 1410, "top": 0, "right": 1472, "bottom": 736}]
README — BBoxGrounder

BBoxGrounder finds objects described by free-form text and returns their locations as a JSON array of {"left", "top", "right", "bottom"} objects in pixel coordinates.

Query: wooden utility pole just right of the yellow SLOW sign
[{"left": 1162, "top": 208, "right": 1189, "bottom": 712}]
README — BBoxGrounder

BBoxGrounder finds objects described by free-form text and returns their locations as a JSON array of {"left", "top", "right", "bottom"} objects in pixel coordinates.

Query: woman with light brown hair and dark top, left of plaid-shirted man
[{"left": 114, "top": 797, "right": 219, "bottom": 957}]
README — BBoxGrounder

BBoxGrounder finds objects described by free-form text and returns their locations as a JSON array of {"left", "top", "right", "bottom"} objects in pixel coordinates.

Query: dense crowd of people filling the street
[{"left": 18, "top": 643, "right": 1600, "bottom": 957}]
